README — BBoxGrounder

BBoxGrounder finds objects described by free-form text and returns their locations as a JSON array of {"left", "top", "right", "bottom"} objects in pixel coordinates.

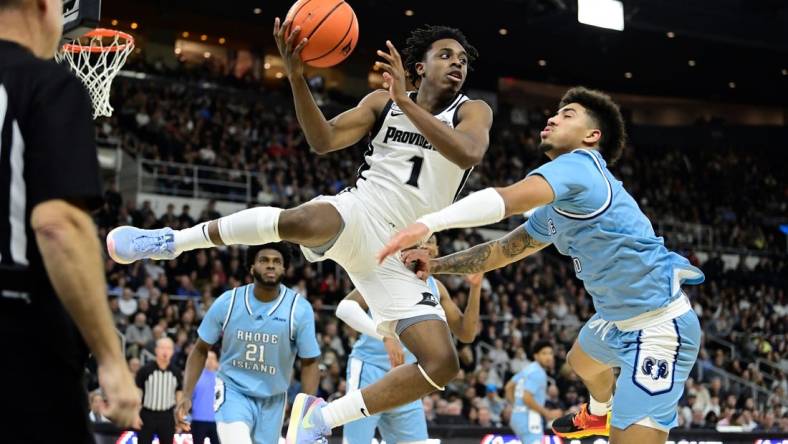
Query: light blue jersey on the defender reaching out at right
[{"left": 524, "top": 149, "right": 704, "bottom": 321}]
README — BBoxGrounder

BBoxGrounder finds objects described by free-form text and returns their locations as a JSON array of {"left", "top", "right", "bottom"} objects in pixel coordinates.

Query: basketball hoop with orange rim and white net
[{"left": 55, "top": 28, "right": 134, "bottom": 119}]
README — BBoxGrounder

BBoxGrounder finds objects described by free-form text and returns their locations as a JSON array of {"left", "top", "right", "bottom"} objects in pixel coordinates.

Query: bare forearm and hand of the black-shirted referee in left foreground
[{"left": 30, "top": 199, "right": 141, "bottom": 427}]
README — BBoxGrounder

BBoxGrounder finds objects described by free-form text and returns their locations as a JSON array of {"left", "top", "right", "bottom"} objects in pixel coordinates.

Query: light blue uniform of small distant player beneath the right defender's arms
[{"left": 509, "top": 362, "right": 547, "bottom": 444}]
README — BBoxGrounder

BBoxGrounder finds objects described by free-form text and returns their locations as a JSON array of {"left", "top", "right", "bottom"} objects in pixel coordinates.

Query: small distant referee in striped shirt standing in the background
[{"left": 137, "top": 337, "right": 183, "bottom": 444}]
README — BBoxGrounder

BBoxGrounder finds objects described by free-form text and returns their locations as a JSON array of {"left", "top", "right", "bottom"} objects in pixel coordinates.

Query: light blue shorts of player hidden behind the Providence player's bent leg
[{"left": 342, "top": 358, "right": 427, "bottom": 444}]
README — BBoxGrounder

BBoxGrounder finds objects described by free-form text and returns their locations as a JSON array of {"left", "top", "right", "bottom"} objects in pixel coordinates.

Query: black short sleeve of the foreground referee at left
[{"left": 22, "top": 66, "right": 102, "bottom": 210}]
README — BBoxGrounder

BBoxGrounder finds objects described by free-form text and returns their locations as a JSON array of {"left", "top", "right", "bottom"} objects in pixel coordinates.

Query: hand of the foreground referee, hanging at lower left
[{"left": 98, "top": 359, "right": 142, "bottom": 429}]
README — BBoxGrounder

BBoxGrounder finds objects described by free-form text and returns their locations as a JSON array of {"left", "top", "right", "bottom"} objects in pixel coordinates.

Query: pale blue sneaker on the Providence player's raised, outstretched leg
[{"left": 107, "top": 226, "right": 178, "bottom": 264}]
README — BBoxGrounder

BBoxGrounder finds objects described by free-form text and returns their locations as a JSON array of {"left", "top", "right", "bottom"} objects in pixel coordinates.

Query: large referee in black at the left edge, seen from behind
[{"left": 0, "top": 0, "right": 139, "bottom": 443}]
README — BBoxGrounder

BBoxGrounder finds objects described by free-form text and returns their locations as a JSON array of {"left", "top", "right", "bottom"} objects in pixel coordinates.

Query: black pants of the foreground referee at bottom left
[{"left": 0, "top": 292, "right": 95, "bottom": 444}]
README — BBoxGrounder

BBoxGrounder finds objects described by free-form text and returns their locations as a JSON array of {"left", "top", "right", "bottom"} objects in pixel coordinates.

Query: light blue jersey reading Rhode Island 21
[{"left": 197, "top": 284, "right": 320, "bottom": 398}]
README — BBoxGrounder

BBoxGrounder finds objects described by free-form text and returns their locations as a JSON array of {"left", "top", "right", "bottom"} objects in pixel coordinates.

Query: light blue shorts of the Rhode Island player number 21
[{"left": 214, "top": 377, "right": 287, "bottom": 444}]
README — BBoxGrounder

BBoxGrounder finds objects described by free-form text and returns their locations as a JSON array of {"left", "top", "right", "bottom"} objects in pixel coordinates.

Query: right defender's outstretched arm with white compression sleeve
[{"left": 378, "top": 175, "right": 555, "bottom": 262}]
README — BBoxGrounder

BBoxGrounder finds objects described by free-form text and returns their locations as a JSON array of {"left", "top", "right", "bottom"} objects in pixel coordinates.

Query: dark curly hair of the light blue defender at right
[{"left": 558, "top": 86, "right": 627, "bottom": 165}]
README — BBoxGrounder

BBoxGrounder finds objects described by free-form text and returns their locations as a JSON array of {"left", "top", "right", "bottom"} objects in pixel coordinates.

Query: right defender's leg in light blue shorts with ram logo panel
[{"left": 610, "top": 310, "right": 701, "bottom": 444}]
